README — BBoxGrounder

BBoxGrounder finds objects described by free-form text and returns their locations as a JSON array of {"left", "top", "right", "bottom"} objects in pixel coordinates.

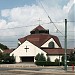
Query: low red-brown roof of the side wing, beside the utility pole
[{"left": 43, "top": 48, "right": 73, "bottom": 55}]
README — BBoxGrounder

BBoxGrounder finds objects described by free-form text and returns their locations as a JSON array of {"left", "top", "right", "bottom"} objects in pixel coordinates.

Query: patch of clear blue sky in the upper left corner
[{"left": 0, "top": 0, "right": 36, "bottom": 10}]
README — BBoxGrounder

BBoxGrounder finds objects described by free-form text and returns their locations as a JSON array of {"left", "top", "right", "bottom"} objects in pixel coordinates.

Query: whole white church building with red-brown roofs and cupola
[{"left": 10, "top": 25, "right": 72, "bottom": 62}]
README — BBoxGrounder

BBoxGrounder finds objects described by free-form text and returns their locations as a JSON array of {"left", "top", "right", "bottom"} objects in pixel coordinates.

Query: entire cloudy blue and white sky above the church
[{"left": 0, "top": 0, "right": 75, "bottom": 48}]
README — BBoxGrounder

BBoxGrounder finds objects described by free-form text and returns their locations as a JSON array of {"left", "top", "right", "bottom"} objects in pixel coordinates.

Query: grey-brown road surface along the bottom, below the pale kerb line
[{"left": 0, "top": 67, "right": 75, "bottom": 75}]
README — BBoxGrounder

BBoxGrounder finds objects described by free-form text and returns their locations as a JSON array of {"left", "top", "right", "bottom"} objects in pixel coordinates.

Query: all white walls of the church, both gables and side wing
[{"left": 10, "top": 38, "right": 62, "bottom": 62}]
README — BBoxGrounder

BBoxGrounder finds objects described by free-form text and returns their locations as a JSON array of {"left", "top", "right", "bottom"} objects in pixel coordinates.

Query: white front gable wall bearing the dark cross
[{"left": 10, "top": 41, "right": 46, "bottom": 62}]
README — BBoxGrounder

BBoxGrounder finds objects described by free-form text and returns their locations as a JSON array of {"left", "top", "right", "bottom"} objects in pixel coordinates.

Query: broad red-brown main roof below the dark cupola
[{"left": 18, "top": 34, "right": 61, "bottom": 47}]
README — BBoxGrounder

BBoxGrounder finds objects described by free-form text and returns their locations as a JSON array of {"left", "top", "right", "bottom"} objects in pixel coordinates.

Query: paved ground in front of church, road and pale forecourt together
[{"left": 0, "top": 63, "right": 75, "bottom": 75}]
